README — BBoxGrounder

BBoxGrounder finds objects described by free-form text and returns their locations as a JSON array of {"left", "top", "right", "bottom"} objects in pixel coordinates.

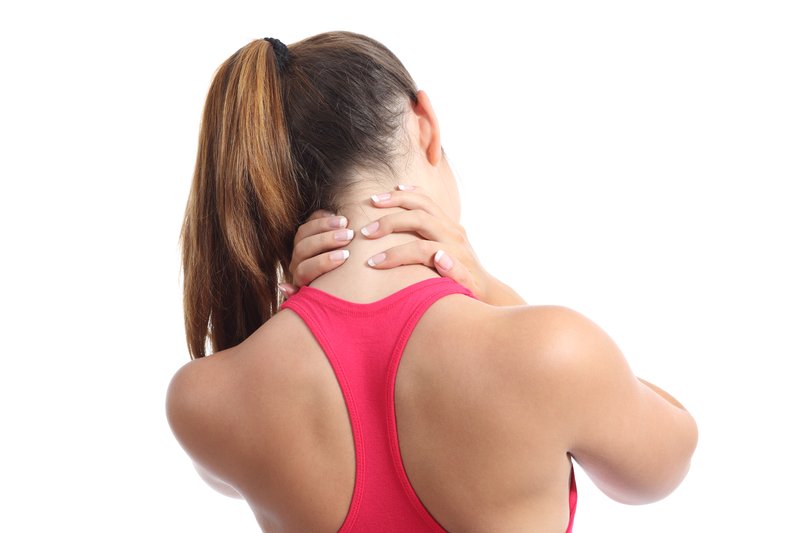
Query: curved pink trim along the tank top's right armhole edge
[{"left": 386, "top": 278, "right": 469, "bottom": 533}]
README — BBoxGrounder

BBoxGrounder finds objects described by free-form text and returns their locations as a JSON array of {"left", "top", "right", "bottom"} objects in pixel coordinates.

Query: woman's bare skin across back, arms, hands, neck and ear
[{"left": 167, "top": 89, "right": 697, "bottom": 532}]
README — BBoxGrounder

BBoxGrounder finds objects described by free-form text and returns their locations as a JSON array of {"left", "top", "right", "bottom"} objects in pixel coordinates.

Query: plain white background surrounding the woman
[{"left": 0, "top": 0, "right": 800, "bottom": 533}]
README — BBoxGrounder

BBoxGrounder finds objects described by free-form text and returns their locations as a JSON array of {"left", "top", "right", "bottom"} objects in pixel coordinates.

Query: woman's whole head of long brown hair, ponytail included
[{"left": 181, "top": 32, "right": 417, "bottom": 358}]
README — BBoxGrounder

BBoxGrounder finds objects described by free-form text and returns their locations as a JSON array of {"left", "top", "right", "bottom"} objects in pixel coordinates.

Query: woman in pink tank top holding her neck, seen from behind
[{"left": 167, "top": 32, "right": 697, "bottom": 532}]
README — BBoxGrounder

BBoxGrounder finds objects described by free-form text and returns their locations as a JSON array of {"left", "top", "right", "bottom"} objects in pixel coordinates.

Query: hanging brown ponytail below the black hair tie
[{"left": 181, "top": 40, "right": 300, "bottom": 359}]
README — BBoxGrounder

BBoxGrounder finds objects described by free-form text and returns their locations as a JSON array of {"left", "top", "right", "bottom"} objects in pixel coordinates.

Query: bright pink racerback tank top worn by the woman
[{"left": 281, "top": 278, "right": 578, "bottom": 533}]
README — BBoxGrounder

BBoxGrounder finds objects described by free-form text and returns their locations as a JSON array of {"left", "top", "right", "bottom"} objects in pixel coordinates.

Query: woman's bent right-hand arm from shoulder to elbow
[{"left": 510, "top": 308, "right": 697, "bottom": 504}]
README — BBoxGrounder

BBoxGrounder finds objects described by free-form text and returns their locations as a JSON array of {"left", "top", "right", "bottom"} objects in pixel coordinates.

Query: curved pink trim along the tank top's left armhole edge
[{"left": 276, "top": 300, "right": 366, "bottom": 533}]
